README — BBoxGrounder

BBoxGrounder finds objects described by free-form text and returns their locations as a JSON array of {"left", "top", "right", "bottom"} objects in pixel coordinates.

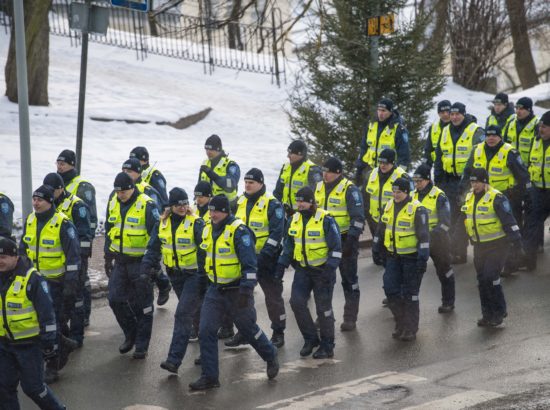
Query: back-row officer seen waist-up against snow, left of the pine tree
[{"left": 199, "top": 134, "right": 241, "bottom": 212}]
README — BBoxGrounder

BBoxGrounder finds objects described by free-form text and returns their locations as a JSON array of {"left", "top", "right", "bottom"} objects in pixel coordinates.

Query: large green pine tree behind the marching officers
[{"left": 289, "top": 0, "right": 445, "bottom": 172}]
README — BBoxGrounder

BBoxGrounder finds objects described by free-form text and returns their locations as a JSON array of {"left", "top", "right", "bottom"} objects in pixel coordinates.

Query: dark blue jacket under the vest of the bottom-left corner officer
[{"left": 0, "top": 256, "right": 57, "bottom": 348}]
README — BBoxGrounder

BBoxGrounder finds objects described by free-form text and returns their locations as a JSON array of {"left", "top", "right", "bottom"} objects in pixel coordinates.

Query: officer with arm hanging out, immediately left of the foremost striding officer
[{"left": 141, "top": 187, "right": 206, "bottom": 373}]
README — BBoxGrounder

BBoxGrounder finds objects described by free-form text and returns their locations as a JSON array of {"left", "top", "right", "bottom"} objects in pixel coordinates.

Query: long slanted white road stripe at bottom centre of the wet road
[{"left": 258, "top": 372, "right": 427, "bottom": 410}]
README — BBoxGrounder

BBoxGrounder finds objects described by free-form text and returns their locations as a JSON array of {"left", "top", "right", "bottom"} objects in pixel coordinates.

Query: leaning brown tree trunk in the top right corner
[{"left": 506, "top": 0, "right": 539, "bottom": 89}]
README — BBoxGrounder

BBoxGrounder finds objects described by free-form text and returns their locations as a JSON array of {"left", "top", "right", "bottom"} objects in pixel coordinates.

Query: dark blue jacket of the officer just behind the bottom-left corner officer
[{"left": 19, "top": 205, "right": 80, "bottom": 282}]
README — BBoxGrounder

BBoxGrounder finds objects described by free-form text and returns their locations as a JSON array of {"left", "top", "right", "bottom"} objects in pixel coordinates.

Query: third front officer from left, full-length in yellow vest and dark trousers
[{"left": 105, "top": 172, "right": 160, "bottom": 359}]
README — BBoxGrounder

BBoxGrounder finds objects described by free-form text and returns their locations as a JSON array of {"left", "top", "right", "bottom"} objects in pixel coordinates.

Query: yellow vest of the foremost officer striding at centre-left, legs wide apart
[{"left": 201, "top": 219, "right": 243, "bottom": 285}]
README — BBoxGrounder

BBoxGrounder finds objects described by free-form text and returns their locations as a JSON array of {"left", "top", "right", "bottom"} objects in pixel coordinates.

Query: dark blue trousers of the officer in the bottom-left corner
[{"left": 0, "top": 341, "right": 65, "bottom": 410}]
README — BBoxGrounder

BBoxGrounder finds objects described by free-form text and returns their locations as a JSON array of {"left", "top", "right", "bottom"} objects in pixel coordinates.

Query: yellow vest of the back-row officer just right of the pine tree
[{"left": 439, "top": 123, "right": 479, "bottom": 176}]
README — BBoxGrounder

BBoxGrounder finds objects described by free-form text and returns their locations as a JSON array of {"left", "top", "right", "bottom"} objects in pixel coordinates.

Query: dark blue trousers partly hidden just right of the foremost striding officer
[{"left": 258, "top": 255, "right": 286, "bottom": 333}]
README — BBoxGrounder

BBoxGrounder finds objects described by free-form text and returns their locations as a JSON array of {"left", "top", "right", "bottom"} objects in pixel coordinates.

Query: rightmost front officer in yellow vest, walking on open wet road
[{"left": 462, "top": 168, "right": 522, "bottom": 327}]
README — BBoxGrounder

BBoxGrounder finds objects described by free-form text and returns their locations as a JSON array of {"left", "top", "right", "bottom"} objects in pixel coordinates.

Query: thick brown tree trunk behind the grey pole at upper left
[{"left": 5, "top": 0, "right": 52, "bottom": 105}]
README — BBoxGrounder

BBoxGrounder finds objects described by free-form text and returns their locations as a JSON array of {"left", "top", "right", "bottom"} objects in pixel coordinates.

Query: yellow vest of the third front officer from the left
[{"left": 108, "top": 194, "right": 153, "bottom": 256}]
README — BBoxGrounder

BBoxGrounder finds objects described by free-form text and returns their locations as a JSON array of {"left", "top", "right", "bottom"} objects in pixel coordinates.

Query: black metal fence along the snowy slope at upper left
[{"left": 0, "top": 0, "right": 285, "bottom": 84}]
